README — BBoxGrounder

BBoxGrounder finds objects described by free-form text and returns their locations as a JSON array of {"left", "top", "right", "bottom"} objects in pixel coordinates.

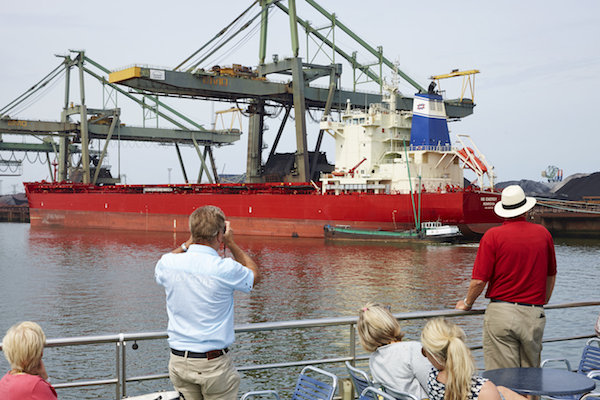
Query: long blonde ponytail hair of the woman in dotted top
[{"left": 421, "top": 318, "right": 475, "bottom": 400}]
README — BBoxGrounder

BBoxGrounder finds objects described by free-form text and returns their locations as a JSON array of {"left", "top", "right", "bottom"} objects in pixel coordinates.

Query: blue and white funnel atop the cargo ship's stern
[{"left": 410, "top": 93, "right": 450, "bottom": 146}]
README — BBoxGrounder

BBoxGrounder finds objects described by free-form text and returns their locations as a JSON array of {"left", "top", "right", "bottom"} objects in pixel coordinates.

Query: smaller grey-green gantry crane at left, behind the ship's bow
[{"left": 0, "top": 50, "right": 241, "bottom": 184}]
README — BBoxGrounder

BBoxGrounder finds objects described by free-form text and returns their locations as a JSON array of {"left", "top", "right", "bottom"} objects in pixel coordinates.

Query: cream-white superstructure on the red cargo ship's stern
[{"left": 320, "top": 85, "right": 491, "bottom": 193}]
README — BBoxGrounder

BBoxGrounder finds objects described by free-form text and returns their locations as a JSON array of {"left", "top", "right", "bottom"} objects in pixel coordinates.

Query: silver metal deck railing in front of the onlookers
[{"left": 5, "top": 299, "right": 600, "bottom": 399}]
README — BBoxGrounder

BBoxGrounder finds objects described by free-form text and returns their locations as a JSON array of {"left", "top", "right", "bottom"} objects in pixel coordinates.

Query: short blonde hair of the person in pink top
[{"left": 2, "top": 321, "right": 46, "bottom": 373}]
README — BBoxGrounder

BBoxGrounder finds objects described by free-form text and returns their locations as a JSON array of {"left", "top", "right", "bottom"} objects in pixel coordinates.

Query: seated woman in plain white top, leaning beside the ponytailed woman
[{"left": 358, "top": 303, "right": 432, "bottom": 399}]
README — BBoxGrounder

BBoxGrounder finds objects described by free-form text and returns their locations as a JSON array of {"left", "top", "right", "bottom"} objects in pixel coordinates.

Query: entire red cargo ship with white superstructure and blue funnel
[{"left": 25, "top": 86, "right": 501, "bottom": 237}]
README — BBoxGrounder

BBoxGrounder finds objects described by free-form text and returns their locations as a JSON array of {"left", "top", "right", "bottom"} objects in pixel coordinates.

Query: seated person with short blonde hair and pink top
[{"left": 0, "top": 321, "right": 57, "bottom": 400}]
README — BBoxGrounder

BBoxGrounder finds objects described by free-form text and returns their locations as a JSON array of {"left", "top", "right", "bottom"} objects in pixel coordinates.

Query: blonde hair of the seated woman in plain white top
[{"left": 358, "top": 303, "right": 404, "bottom": 352}]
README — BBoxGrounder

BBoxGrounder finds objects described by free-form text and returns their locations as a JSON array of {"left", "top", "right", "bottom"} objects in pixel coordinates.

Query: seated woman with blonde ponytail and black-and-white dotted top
[{"left": 421, "top": 318, "right": 526, "bottom": 400}]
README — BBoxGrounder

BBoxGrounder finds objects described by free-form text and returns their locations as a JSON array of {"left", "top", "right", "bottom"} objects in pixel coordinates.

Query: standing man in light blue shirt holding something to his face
[{"left": 155, "top": 206, "right": 260, "bottom": 400}]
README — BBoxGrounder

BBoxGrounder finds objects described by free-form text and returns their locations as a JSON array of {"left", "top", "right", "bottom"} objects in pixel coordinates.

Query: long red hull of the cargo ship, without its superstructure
[{"left": 25, "top": 182, "right": 501, "bottom": 238}]
